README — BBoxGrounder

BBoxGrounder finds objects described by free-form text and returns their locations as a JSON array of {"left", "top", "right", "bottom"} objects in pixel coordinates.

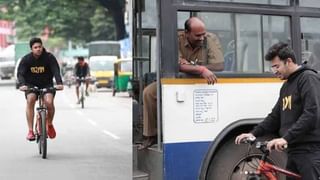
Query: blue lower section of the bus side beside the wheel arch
[{"left": 163, "top": 142, "right": 211, "bottom": 180}]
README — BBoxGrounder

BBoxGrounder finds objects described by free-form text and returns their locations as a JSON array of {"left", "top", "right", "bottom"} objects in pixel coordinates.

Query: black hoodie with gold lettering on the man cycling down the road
[{"left": 18, "top": 49, "right": 62, "bottom": 88}]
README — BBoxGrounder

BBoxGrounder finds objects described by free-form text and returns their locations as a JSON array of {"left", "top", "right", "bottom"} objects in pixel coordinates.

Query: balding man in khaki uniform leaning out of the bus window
[{"left": 139, "top": 17, "right": 223, "bottom": 150}]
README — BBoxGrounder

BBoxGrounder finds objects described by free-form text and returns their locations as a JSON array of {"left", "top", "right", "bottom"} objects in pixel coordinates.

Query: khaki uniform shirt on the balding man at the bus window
[{"left": 178, "top": 31, "right": 223, "bottom": 65}]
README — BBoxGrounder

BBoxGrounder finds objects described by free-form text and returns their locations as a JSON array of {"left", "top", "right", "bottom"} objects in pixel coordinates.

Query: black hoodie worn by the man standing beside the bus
[{"left": 251, "top": 66, "right": 320, "bottom": 148}]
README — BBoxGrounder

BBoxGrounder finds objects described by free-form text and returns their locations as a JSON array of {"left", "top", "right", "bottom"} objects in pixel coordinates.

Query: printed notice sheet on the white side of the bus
[{"left": 193, "top": 89, "right": 218, "bottom": 123}]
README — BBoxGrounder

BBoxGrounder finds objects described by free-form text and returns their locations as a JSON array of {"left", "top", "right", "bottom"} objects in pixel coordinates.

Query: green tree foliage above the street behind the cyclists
[{"left": 0, "top": 0, "right": 116, "bottom": 44}]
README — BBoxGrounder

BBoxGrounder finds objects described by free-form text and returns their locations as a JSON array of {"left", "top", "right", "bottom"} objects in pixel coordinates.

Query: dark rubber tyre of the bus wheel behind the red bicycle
[{"left": 205, "top": 136, "right": 287, "bottom": 180}]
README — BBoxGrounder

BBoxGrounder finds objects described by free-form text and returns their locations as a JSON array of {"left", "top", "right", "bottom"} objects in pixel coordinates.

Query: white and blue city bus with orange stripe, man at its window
[{"left": 132, "top": 0, "right": 320, "bottom": 180}]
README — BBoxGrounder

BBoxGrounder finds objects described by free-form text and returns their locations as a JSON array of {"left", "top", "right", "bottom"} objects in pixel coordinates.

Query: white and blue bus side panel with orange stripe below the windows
[{"left": 161, "top": 79, "right": 282, "bottom": 180}]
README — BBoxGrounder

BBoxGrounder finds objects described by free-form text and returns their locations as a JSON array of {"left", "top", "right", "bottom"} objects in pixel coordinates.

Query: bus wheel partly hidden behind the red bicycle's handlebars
[{"left": 206, "top": 136, "right": 287, "bottom": 180}]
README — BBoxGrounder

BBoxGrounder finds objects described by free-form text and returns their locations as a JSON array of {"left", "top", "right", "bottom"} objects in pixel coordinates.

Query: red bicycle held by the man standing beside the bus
[{"left": 229, "top": 138, "right": 302, "bottom": 180}]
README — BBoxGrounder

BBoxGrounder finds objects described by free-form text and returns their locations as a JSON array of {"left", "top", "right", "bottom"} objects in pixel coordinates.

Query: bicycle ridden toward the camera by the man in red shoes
[{"left": 28, "top": 87, "right": 57, "bottom": 159}]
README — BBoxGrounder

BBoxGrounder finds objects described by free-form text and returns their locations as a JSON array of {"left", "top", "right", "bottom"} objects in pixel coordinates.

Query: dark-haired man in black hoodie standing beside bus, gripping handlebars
[{"left": 235, "top": 42, "right": 320, "bottom": 180}]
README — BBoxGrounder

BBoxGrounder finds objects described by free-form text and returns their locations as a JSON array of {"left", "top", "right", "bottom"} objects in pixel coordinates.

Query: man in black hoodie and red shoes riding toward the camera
[{"left": 17, "top": 38, "right": 63, "bottom": 141}]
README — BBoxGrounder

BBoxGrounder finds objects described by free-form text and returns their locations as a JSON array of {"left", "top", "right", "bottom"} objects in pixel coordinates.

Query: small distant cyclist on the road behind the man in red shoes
[{"left": 74, "top": 56, "right": 90, "bottom": 104}]
